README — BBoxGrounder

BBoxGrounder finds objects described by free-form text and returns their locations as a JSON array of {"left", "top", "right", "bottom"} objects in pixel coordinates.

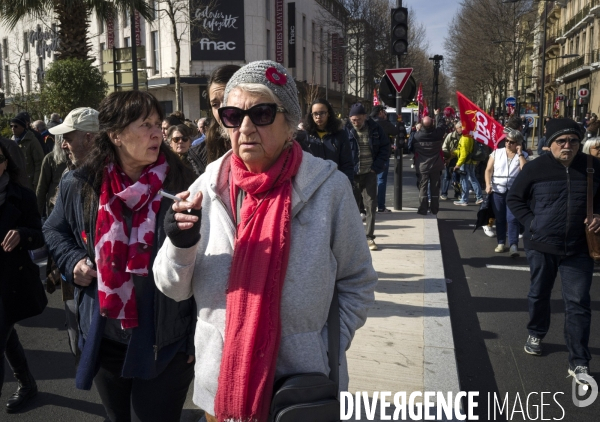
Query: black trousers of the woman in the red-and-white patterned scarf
[{"left": 94, "top": 339, "right": 194, "bottom": 422}]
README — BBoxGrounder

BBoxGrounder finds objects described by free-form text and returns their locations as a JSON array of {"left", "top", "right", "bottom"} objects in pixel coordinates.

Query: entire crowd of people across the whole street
[{"left": 0, "top": 60, "right": 600, "bottom": 422}]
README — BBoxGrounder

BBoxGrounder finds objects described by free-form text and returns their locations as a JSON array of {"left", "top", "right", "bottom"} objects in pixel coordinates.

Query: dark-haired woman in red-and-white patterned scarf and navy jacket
[{"left": 44, "top": 91, "right": 196, "bottom": 422}]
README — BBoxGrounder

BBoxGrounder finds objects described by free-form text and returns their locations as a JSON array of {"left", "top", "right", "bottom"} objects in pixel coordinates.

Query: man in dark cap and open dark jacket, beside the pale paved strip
[{"left": 346, "top": 103, "right": 390, "bottom": 251}]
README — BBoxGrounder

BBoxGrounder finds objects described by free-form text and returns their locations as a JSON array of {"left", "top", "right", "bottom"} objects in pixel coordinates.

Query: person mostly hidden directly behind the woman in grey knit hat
[{"left": 205, "top": 64, "right": 240, "bottom": 164}]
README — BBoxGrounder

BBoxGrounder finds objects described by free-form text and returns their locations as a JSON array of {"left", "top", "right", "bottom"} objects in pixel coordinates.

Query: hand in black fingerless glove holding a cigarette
[{"left": 164, "top": 191, "right": 202, "bottom": 248}]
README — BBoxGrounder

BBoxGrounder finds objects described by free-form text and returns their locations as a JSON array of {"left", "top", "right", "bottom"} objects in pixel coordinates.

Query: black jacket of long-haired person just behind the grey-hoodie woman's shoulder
[{"left": 296, "top": 130, "right": 354, "bottom": 183}]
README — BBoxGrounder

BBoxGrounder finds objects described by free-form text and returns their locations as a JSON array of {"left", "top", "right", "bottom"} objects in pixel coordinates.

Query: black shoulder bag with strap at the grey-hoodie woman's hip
[{"left": 269, "top": 287, "right": 340, "bottom": 422}]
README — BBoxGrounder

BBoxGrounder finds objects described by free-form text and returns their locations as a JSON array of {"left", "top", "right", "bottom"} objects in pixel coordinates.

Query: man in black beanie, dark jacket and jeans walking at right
[{"left": 507, "top": 119, "right": 600, "bottom": 384}]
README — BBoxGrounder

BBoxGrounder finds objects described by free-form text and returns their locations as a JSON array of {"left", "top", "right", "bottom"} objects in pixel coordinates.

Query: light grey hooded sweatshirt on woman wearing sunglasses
[{"left": 153, "top": 151, "right": 377, "bottom": 415}]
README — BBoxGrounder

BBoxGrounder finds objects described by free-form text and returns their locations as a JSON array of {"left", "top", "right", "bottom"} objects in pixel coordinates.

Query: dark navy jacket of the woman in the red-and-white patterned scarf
[{"left": 43, "top": 169, "right": 196, "bottom": 390}]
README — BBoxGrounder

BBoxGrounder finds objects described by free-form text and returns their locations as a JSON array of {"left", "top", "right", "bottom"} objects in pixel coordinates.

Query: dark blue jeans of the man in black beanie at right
[{"left": 525, "top": 249, "right": 594, "bottom": 369}]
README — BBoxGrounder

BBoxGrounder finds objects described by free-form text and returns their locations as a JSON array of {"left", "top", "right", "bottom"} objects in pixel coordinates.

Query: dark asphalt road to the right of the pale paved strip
[{"left": 438, "top": 181, "right": 600, "bottom": 422}]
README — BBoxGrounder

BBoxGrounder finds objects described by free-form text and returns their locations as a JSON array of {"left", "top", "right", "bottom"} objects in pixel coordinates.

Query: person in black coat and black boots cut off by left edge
[{"left": 0, "top": 144, "right": 47, "bottom": 413}]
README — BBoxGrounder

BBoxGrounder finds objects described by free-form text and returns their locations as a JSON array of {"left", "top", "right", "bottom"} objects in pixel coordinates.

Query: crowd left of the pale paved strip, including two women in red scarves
[{"left": 0, "top": 61, "right": 390, "bottom": 422}]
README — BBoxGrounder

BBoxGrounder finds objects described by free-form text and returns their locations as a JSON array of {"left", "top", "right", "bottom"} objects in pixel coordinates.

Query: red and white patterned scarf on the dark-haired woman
[{"left": 94, "top": 154, "right": 169, "bottom": 329}]
